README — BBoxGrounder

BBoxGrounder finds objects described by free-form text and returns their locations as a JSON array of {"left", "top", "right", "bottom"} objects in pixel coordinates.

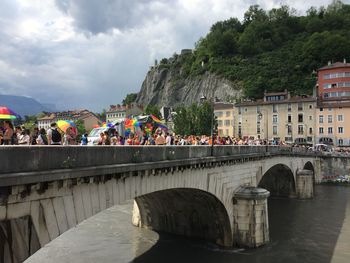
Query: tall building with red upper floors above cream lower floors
[{"left": 316, "top": 60, "right": 350, "bottom": 146}]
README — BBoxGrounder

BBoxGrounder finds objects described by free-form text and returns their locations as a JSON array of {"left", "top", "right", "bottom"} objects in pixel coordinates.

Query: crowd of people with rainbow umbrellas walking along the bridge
[{"left": 0, "top": 120, "right": 284, "bottom": 145}]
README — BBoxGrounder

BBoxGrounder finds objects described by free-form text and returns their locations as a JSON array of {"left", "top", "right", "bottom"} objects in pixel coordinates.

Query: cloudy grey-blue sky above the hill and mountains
[{"left": 0, "top": 0, "right": 344, "bottom": 111}]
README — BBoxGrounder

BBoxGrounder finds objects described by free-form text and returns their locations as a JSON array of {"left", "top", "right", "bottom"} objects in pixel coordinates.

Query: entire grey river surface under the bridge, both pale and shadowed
[{"left": 26, "top": 185, "right": 350, "bottom": 263}]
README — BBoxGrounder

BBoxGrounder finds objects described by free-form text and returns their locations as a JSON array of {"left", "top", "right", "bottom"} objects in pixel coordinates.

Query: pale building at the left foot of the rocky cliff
[{"left": 106, "top": 103, "right": 143, "bottom": 123}]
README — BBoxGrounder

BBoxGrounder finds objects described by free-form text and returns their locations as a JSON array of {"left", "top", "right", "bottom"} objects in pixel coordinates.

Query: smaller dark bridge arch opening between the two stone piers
[{"left": 258, "top": 164, "right": 296, "bottom": 197}]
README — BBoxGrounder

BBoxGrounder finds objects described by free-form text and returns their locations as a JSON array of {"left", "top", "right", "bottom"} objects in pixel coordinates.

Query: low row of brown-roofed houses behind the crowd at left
[{"left": 38, "top": 109, "right": 102, "bottom": 131}]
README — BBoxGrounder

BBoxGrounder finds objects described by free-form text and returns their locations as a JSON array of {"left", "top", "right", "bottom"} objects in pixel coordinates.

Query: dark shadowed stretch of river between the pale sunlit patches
[{"left": 133, "top": 186, "right": 350, "bottom": 263}]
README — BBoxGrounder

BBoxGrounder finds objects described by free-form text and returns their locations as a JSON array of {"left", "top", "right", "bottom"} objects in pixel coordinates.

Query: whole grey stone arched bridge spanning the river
[{"left": 0, "top": 146, "right": 342, "bottom": 262}]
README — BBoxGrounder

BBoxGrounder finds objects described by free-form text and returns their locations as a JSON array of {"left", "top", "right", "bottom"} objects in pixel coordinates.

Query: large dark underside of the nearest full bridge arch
[{"left": 134, "top": 188, "right": 233, "bottom": 246}]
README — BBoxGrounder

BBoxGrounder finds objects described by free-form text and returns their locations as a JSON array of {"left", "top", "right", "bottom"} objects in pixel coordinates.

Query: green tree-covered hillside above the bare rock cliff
[{"left": 160, "top": 1, "right": 350, "bottom": 98}]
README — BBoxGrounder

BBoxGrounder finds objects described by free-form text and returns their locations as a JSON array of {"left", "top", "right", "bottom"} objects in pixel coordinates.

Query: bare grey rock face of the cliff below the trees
[{"left": 136, "top": 65, "right": 241, "bottom": 107}]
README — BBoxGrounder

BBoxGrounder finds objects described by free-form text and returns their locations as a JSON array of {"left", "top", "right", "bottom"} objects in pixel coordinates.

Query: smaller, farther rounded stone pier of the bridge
[{"left": 296, "top": 170, "right": 314, "bottom": 199}]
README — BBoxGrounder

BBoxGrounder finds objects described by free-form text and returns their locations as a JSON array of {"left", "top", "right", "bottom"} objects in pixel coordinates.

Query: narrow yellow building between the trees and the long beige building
[{"left": 214, "top": 102, "right": 235, "bottom": 137}]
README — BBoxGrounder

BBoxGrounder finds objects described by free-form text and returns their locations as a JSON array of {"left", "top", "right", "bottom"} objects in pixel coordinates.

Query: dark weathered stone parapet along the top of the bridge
[{"left": 0, "top": 145, "right": 312, "bottom": 174}]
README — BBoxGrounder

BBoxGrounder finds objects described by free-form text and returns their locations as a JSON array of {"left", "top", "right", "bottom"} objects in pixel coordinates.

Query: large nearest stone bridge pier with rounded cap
[{"left": 233, "top": 187, "right": 270, "bottom": 248}]
